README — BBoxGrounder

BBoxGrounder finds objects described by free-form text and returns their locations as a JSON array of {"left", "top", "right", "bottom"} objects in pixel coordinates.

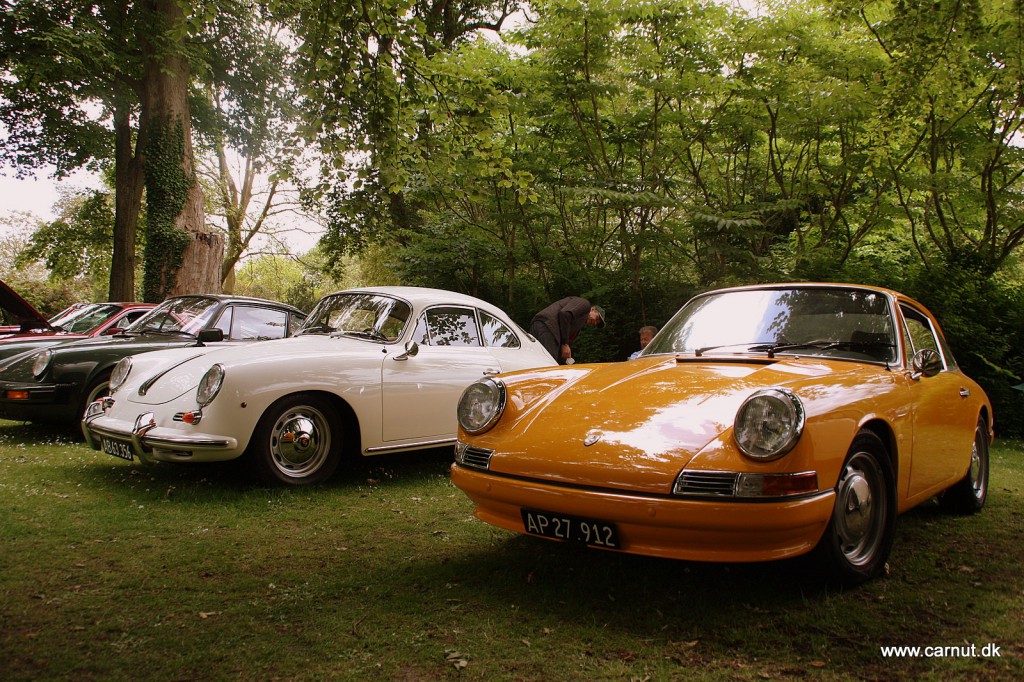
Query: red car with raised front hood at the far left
[{"left": 0, "top": 282, "right": 154, "bottom": 358}]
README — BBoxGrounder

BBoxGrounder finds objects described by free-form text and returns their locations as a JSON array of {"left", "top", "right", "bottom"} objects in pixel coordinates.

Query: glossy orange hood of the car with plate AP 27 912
[{"left": 483, "top": 356, "right": 890, "bottom": 494}]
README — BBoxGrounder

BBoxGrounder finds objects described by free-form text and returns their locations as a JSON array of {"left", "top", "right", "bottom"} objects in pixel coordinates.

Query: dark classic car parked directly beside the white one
[{"left": 0, "top": 294, "right": 305, "bottom": 425}]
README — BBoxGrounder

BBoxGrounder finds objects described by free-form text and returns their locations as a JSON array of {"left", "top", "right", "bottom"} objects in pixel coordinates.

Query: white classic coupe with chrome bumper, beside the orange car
[{"left": 83, "top": 287, "right": 554, "bottom": 485}]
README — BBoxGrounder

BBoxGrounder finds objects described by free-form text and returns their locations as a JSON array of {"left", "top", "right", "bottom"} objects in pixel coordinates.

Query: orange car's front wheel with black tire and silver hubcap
[{"left": 814, "top": 431, "right": 896, "bottom": 586}]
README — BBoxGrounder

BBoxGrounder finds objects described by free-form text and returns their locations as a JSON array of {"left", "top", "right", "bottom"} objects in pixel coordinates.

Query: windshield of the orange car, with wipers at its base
[{"left": 644, "top": 287, "right": 897, "bottom": 363}]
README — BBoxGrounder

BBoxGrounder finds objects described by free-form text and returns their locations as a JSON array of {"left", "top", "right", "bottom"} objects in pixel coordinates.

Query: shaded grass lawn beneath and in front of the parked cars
[{"left": 0, "top": 422, "right": 1024, "bottom": 682}]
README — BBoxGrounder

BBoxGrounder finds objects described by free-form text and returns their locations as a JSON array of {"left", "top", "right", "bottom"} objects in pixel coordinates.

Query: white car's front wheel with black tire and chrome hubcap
[{"left": 248, "top": 393, "right": 345, "bottom": 485}]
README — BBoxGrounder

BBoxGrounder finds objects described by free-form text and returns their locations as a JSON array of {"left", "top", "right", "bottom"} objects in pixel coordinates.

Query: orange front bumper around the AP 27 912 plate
[{"left": 452, "top": 464, "right": 836, "bottom": 562}]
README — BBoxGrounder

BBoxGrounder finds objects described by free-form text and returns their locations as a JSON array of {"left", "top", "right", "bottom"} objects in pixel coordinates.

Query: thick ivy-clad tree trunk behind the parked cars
[{"left": 139, "top": 0, "right": 224, "bottom": 301}]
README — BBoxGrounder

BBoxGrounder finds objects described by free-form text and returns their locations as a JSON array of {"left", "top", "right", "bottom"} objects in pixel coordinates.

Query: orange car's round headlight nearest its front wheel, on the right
[{"left": 732, "top": 388, "right": 804, "bottom": 461}]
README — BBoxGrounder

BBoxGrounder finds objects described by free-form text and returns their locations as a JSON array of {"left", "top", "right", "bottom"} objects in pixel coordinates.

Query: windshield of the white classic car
[{"left": 299, "top": 292, "right": 412, "bottom": 342}]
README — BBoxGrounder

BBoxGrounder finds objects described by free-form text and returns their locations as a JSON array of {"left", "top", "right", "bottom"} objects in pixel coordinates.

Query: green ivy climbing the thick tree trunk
[{"left": 142, "top": 119, "right": 196, "bottom": 302}]
